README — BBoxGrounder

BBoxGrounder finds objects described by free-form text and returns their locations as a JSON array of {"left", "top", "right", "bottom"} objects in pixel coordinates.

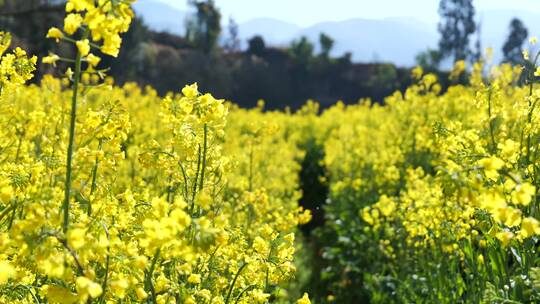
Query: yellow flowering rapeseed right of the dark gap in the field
[{"left": 316, "top": 50, "right": 540, "bottom": 303}]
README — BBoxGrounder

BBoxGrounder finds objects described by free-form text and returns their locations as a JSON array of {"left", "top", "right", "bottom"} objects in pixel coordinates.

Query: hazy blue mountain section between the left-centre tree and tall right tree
[{"left": 234, "top": 18, "right": 437, "bottom": 65}]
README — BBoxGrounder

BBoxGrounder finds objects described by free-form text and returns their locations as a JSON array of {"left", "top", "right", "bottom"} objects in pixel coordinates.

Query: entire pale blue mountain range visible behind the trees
[{"left": 135, "top": 0, "right": 540, "bottom": 66}]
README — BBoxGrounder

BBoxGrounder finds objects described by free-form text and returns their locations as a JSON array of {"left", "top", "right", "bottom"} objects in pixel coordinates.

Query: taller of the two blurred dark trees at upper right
[{"left": 438, "top": 0, "right": 476, "bottom": 61}]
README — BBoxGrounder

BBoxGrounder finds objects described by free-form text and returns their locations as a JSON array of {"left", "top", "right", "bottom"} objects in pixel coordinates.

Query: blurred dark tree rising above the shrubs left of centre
[{"left": 186, "top": 0, "right": 221, "bottom": 54}]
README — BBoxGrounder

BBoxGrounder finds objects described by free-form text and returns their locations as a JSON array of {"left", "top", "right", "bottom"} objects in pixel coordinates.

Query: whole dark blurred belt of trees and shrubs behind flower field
[{"left": 0, "top": 0, "right": 528, "bottom": 109}]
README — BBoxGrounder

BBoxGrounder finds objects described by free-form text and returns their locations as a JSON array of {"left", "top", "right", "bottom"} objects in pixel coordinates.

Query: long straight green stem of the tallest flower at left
[{"left": 62, "top": 41, "right": 86, "bottom": 233}]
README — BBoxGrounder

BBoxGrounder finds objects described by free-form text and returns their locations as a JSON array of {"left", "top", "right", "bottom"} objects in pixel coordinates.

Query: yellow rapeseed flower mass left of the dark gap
[{"left": 0, "top": 77, "right": 310, "bottom": 303}]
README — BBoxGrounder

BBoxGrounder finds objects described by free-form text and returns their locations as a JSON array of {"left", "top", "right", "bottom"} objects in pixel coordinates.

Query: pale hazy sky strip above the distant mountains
[{"left": 154, "top": 0, "right": 540, "bottom": 26}]
